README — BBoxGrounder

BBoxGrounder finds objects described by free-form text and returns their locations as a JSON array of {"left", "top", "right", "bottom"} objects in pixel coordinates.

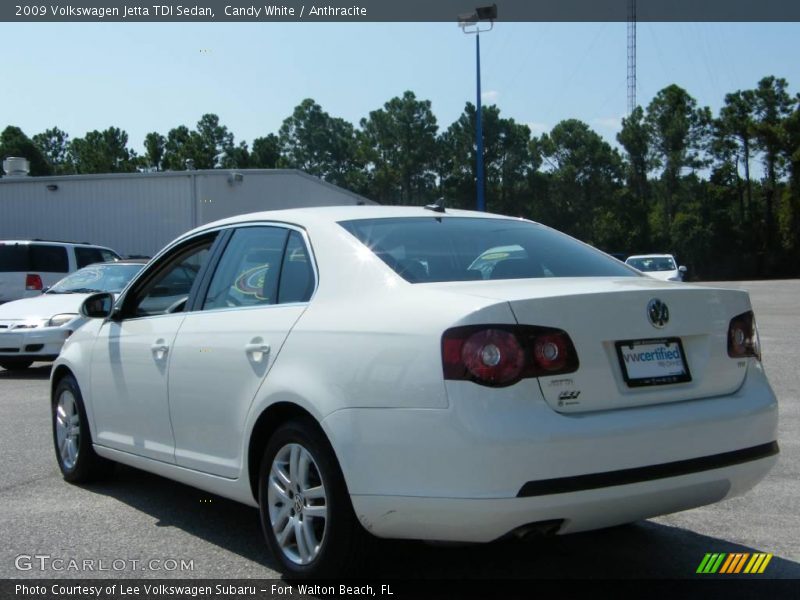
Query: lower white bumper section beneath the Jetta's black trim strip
[{"left": 352, "top": 456, "right": 777, "bottom": 542}]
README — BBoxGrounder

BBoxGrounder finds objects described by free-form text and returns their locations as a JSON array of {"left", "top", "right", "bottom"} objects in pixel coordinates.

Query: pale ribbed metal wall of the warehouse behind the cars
[{"left": 0, "top": 169, "right": 373, "bottom": 256}]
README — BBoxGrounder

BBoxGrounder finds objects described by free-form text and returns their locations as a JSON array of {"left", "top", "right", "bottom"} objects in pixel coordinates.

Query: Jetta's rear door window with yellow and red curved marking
[{"left": 203, "top": 227, "right": 288, "bottom": 310}]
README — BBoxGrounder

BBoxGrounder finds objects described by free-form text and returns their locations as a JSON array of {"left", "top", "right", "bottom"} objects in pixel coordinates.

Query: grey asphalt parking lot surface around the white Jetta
[{"left": 0, "top": 280, "right": 800, "bottom": 579}]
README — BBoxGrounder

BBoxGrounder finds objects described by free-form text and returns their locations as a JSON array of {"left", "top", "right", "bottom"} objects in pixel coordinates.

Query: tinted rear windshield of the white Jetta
[{"left": 339, "top": 217, "right": 638, "bottom": 283}]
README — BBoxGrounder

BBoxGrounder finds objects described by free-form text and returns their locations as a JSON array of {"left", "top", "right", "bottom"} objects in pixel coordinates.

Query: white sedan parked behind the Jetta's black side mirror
[{"left": 0, "top": 260, "right": 144, "bottom": 371}]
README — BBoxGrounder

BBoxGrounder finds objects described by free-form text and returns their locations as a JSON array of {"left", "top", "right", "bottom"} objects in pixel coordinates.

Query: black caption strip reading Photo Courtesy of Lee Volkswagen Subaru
[{"left": 0, "top": 576, "right": 800, "bottom": 600}]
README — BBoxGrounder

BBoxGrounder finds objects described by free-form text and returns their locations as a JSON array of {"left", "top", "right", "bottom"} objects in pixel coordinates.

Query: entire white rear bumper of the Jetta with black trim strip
[{"left": 323, "top": 364, "right": 778, "bottom": 541}]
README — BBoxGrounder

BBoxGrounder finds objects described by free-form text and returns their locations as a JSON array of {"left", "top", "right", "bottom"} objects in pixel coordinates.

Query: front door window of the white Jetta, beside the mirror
[{"left": 123, "top": 233, "right": 217, "bottom": 317}]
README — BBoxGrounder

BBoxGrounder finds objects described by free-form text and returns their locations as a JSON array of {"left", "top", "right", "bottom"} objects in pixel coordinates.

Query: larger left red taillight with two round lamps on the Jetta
[{"left": 442, "top": 325, "right": 578, "bottom": 387}]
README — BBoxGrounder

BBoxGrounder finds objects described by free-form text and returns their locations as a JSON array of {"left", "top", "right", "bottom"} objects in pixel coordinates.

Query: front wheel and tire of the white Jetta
[{"left": 51, "top": 375, "right": 114, "bottom": 483}]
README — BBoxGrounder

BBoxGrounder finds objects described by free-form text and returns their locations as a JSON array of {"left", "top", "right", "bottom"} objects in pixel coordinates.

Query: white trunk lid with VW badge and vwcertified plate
[{"left": 429, "top": 277, "right": 750, "bottom": 413}]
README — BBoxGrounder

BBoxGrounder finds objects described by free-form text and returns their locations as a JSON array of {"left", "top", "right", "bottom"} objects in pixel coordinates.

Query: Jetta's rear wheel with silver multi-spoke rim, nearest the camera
[{"left": 258, "top": 419, "right": 371, "bottom": 577}]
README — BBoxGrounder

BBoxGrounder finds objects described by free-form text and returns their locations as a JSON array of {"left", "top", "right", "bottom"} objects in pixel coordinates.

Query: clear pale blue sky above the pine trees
[{"left": 0, "top": 22, "right": 800, "bottom": 153}]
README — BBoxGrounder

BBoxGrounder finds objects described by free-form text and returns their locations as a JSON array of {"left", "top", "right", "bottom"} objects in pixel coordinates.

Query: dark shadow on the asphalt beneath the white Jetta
[{"left": 76, "top": 465, "right": 800, "bottom": 580}]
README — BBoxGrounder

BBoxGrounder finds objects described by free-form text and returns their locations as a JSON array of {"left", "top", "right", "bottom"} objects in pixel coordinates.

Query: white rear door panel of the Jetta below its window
[{"left": 169, "top": 304, "right": 306, "bottom": 478}]
